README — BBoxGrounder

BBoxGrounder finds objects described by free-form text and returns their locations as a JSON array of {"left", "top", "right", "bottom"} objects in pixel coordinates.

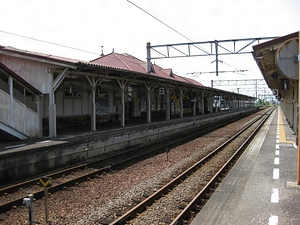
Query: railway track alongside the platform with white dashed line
[{"left": 108, "top": 106, "right": 271, "bottom": 225}]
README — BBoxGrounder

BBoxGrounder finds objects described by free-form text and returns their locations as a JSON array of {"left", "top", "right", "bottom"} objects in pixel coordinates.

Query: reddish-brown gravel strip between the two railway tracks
[{"left": 0, "top": 114, "right": 256, "bottom": 225}]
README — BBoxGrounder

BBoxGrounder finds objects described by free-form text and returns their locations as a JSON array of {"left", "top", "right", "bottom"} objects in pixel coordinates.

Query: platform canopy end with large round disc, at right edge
[{"left": 253, "top": 32, "right": 299, "bottom": 99}]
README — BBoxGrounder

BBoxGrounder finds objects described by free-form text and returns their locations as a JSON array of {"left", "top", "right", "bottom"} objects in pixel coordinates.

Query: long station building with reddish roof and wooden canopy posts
[{"left": 0, "top": 46, "right": 255, "bottom": 140}]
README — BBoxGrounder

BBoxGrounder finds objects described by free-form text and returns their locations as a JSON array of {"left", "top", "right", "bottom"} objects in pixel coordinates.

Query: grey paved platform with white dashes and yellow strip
[{"left": 191, "top": 107, "right": 300, "bottom": 225}]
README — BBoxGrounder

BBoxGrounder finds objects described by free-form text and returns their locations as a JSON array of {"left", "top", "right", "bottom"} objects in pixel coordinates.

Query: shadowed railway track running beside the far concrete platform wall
[{"left": 0, "top": 108, "right": 253, "bottom": 213}]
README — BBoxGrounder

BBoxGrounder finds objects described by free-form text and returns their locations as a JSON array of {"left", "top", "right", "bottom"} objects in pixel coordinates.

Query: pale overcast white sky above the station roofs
[{"left": 0, "top": 0, "right": 300, "bottom": 95}]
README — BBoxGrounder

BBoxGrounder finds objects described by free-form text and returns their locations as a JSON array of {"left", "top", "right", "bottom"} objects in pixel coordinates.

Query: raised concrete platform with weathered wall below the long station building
[{"left": 0, "top": 107, "right": 259, "bottom": 183}]
